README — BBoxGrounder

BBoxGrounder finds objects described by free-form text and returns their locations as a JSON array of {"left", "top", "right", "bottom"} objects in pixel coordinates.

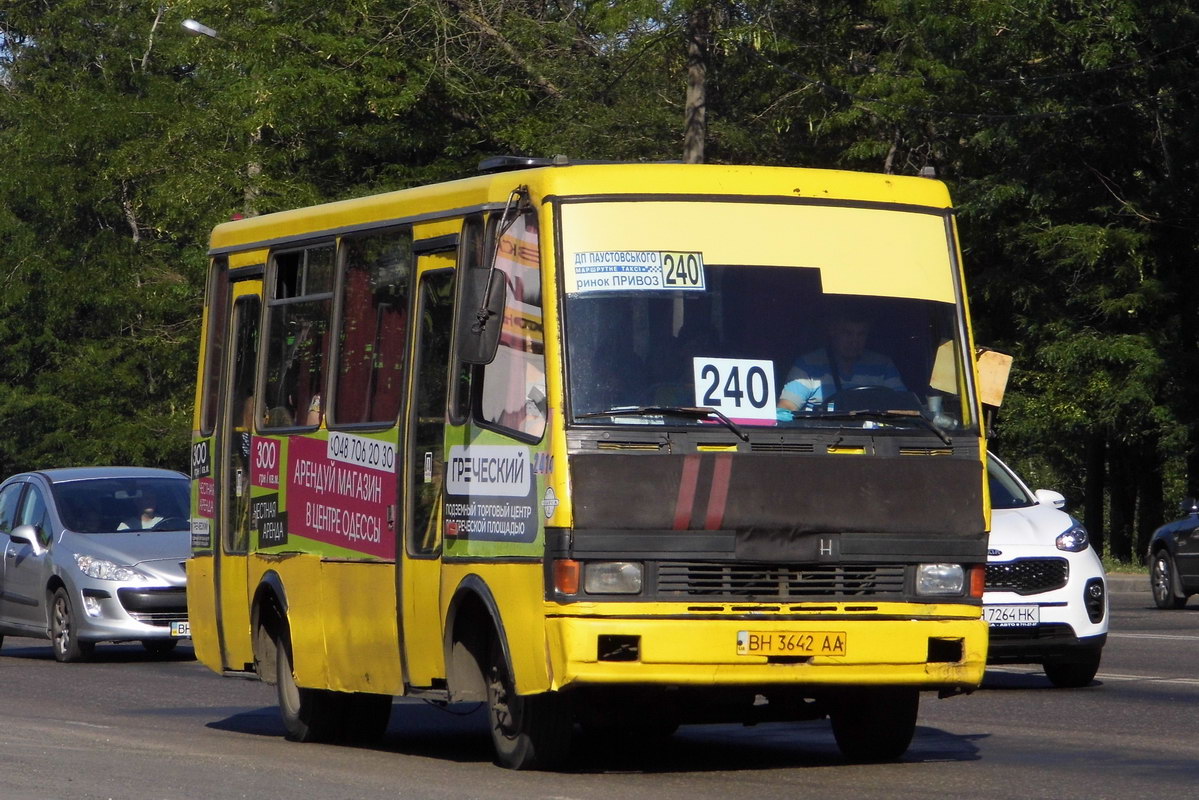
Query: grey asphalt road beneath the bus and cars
[{"left": 0, "top": 582, "right": 1199, "bottom": 800}]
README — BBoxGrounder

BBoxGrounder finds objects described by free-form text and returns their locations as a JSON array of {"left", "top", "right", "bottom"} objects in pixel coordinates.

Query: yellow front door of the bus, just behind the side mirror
[{"left": 399, "top": 253, "right": 454, "bottom": 686}]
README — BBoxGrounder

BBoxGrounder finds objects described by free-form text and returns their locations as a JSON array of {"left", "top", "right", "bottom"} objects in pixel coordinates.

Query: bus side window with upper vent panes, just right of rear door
[{"left": 259, "top": 245, "right": 333, "bottom": 428}]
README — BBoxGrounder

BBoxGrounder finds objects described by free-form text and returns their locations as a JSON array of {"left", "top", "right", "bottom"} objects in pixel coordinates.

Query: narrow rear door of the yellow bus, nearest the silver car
[{"left": 213, "top": 277, "right": 263, "bottom": 670}]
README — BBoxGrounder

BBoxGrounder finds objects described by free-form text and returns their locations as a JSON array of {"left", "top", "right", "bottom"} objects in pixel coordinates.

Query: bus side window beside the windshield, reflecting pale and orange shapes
[{"left": 475, "top": 212, "right": 546, "bottom": 440}]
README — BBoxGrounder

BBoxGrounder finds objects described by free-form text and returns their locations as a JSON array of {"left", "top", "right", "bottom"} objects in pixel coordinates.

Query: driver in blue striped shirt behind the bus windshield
[{"left": 778, "top": 314, "right": 905, "bottom": 421}]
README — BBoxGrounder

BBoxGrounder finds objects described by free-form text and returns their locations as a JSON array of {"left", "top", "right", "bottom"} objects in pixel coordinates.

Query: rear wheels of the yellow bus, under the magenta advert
[{"left": 275, "top": 636, "right": 391, "bottom": 742}]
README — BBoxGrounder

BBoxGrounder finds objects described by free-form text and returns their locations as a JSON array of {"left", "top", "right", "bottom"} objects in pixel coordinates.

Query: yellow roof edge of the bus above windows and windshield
[{"left": 210, "top": 163, "right": 950, "bottom": 253}]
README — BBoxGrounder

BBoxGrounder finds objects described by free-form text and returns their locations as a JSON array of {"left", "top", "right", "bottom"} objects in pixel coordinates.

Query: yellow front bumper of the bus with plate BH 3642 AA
[{"left": 547, "top": 616, "right": 987, "bottom": 691}]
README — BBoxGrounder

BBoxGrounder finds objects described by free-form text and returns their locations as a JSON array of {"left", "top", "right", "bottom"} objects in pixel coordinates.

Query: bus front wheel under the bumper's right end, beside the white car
[{"left": 829, "top": 688, "right": 920, "bottom": 762}]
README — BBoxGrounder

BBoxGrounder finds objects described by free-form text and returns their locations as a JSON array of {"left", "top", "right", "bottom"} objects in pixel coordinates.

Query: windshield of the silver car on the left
[{"left": 53, "top": 477, "right": 191, "bottom": 534}]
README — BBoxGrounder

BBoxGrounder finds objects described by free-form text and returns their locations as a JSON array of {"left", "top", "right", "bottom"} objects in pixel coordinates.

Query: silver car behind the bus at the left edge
[{"left": 0, "top": 467, "right": 191, "bottom": 661}]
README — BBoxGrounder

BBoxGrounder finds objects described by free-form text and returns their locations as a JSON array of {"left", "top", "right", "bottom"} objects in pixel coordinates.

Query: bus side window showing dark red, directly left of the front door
[{"left": 330, "top": 229, "right": 412, "bottom": 425}]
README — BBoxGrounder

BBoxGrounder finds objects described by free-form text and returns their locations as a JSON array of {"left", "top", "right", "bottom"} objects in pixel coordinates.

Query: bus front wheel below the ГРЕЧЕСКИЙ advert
[{"left": 484, "top": 639, "right": 572, "bottom": 770}]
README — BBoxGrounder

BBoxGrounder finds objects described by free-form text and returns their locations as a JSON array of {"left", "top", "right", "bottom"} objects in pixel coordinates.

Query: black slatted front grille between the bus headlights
[{"left": 657, "top": 561, "right": 905, "bottom": 601}]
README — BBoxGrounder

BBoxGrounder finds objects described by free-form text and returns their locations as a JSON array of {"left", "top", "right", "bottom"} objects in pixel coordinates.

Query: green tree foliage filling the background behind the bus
[{"left": 0, "top": 0, "right": 1199, "bottom": 557}]
